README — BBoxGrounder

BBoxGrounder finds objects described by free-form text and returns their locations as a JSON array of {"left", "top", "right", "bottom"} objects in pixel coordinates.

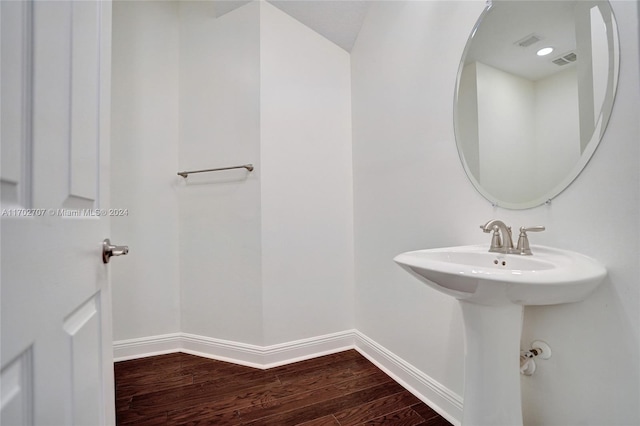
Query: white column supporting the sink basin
[{"left": 459, "top": 300, "right": 524, "bottom": 426}]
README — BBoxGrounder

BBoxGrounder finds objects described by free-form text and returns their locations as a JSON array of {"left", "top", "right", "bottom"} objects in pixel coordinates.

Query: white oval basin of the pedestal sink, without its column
[{"left": 393, "top": 245, "right": 606, "bottom": 305}]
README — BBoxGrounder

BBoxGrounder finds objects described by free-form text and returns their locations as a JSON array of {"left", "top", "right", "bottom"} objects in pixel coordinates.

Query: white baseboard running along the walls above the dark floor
[{"left": 113, "top": 330, "right": 462, "bottom": 425}]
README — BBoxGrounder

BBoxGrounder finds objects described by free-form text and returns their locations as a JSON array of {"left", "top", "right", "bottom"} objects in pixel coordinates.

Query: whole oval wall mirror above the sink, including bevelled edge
[{"left": 454, "top": 0, "right": 619, "bottom": 209}]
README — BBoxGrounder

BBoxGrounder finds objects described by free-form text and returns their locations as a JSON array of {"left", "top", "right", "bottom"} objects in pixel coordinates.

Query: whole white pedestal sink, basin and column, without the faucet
[{"left": 394, "top": 245, "right": 606, "bottom": 426}]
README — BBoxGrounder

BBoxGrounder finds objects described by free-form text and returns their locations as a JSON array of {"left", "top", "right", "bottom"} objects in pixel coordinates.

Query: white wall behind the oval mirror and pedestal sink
[{"left": 352, "top": 0, "right": 640, "bottom": 425}]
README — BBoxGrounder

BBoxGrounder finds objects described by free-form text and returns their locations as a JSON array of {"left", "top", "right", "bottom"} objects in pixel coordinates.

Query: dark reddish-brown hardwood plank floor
[{"left": 115, "top": 350, "right": 456, "bottom": 426}]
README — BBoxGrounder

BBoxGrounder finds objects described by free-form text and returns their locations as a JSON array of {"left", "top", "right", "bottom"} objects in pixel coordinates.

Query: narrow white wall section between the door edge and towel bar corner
[{"left": 110, "top": 1, "right": 180, "bottom": 340}]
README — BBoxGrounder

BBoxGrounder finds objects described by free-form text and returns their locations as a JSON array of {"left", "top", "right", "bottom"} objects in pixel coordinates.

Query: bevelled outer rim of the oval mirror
[{"left": 453, "top": 0, "right": 620, "bottom": 210}]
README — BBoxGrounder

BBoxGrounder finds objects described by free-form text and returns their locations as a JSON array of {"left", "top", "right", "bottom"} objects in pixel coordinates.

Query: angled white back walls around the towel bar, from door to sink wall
[{"left": 112, "top": 2, "right": 353, "bottom": 355}]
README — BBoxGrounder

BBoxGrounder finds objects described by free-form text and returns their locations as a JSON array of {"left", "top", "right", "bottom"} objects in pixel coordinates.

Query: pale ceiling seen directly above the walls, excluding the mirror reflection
[{"left": 214, "top": 0, "right": 367, "bottom": 52}]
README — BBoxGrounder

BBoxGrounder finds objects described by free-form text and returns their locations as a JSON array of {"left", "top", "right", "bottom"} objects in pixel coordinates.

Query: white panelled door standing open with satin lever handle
[{"left": 0, "top": 0, "right": 115, "bottom": 426}]
